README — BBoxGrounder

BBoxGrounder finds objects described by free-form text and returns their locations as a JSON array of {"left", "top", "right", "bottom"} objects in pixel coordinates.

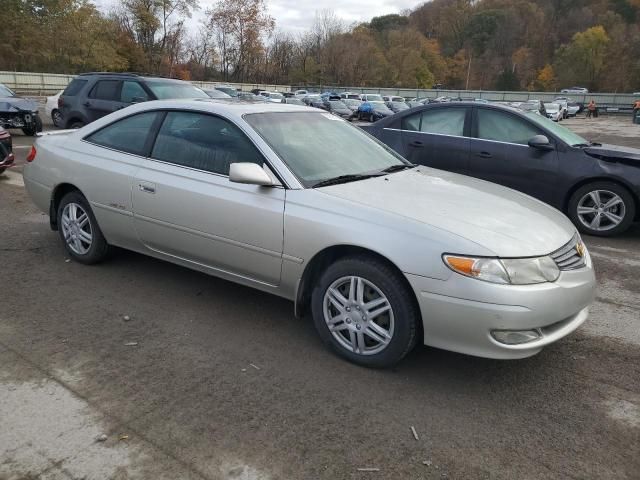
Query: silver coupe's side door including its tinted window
[{"left": 132, "top": 111, "right": 285, "bottom": 286}]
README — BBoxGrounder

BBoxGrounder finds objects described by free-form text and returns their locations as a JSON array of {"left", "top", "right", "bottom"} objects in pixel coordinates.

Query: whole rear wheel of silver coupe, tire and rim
[{"left": 56, "top": 191, "right": 109, "bottom": 265}]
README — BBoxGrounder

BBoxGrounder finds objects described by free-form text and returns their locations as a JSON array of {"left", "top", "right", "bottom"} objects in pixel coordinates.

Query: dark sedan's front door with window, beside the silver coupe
[{"left": 469, "top": 107, "right": 558, "bottom": 203}]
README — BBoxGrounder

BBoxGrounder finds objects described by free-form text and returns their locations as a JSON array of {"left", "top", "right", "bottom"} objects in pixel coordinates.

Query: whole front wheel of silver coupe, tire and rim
[{"left": 311, "top": 255, "right": 420, "bottom": 368}]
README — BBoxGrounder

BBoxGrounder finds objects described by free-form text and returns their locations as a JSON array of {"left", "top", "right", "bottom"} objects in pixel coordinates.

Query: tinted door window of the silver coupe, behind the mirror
[{"left": 151, "top": 112, "right": 264, "bottom": 175}]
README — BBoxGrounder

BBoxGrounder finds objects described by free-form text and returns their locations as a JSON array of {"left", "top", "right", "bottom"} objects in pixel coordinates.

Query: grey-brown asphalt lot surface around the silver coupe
[{"left": 0, "top": 113, "right": 640, "bottom": 480}]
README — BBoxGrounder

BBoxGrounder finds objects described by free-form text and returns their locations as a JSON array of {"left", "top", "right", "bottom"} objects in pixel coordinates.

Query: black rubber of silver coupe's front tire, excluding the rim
[{"left": 311, "top": 256, "right": 420, "bottom": 368}]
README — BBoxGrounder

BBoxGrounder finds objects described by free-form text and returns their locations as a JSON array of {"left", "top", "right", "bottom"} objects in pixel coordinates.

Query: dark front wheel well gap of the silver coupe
[{"left": 295, "top": 245, "right": 422, "bottom": 335}]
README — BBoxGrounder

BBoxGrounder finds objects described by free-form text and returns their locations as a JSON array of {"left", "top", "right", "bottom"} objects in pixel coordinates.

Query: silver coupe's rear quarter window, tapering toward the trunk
[{"left": 85, "top": 112, "right": 160, "bottom": 155}]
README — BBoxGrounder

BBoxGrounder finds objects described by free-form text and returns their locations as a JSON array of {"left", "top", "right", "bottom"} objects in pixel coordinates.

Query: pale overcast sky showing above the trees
[{"left": 94, "top": 0, "right": 425, "bottom": 33}]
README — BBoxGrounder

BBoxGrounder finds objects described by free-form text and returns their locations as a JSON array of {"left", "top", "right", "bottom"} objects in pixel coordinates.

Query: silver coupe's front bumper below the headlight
[{"left": 406, "top": 258, "right": 596, "bottom": 359}]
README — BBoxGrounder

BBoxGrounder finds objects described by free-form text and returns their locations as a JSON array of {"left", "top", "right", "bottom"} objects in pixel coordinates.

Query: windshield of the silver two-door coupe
[{"left": 244, "top": 112, "right": 405, "bottom": 187}]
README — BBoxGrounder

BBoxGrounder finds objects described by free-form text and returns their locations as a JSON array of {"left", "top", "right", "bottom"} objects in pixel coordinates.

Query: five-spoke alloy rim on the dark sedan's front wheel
[{"left": 577, "top": 190, "right": 626, "bottom": 232}]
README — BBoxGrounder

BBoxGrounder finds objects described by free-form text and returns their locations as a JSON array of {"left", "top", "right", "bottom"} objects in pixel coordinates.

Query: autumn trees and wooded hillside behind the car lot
[{"left": 0, "top": 0, "right": 640, "bottom": 92}]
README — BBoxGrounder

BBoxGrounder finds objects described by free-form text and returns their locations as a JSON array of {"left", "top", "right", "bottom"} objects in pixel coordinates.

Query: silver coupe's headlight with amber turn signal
[{"left": 442, "top": 255, "right": 560, "bottom": 285}]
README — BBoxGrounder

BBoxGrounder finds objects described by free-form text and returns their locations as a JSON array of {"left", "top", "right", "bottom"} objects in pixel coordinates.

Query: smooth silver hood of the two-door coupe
[{"left": 318, "top": 167, "right": 576, "bottom": 257}]
